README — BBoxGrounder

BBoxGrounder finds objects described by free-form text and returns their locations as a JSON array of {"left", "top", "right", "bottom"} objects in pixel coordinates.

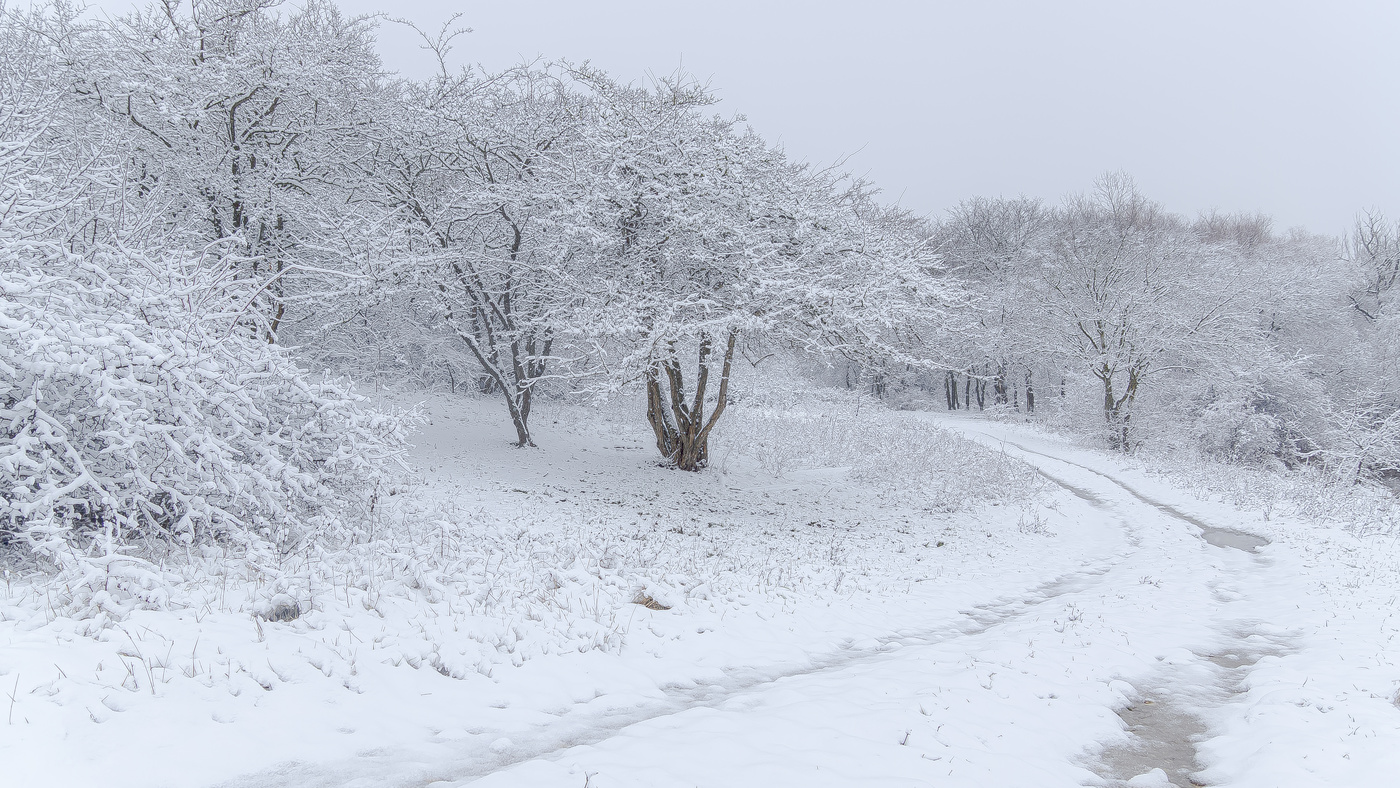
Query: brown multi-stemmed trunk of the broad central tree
[{"left": 647, "top": 330, "right": 739, "bottom": 470}]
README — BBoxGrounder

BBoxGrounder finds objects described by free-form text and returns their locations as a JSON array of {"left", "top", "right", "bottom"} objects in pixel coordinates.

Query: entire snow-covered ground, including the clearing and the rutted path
[{"left": 0, "top": 397, "right": 1400, "bottom": 788}]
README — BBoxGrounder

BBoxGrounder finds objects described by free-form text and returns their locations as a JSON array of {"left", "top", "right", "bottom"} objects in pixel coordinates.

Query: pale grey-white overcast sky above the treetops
[{"left": 90, "top": 0, "right": 1400, "bottom": 234}]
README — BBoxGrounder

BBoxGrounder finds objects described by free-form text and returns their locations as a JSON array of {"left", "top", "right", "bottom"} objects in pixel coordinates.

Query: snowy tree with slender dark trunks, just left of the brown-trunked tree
[{"left": 371, "top": 67, "right": 589, "bottom": 446}]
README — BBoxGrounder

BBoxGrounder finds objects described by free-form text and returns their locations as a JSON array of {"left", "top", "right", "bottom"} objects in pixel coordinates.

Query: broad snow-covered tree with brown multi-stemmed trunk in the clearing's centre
[{"left": 571, "top": 74, "right": 963, "bottom": 470}]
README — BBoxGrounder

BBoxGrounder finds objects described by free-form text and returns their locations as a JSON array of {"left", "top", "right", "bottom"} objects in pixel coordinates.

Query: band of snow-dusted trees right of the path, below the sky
[{"left": 925, "top": 174, "right": 1400, "bottom": 479}]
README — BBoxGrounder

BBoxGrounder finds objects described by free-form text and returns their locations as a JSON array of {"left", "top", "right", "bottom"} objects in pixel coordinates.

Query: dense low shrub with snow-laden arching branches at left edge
[{"left": 0, "top": 256, "right": 403, "bottom": 554}]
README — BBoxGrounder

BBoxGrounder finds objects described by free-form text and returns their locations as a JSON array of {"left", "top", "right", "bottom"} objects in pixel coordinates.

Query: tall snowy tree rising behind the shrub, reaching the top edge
[{"left": 59, "top": 0, "right": 384, "bottom": 342}]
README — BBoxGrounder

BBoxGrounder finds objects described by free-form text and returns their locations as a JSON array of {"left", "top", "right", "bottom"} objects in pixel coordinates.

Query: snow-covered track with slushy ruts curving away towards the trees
[{"left": 436, "top": 425, "right": 1282, "bottom": 787}]
